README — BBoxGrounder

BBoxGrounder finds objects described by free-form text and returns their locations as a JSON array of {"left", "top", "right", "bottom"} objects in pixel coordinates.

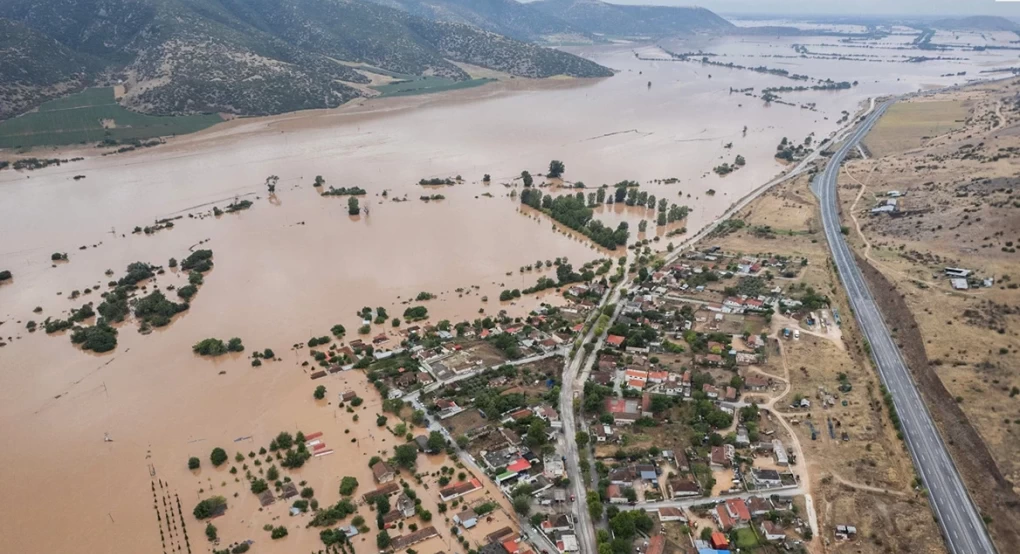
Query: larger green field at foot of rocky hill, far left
[{"left": 0, "top": 88, "right": 222, "bottom": 148}]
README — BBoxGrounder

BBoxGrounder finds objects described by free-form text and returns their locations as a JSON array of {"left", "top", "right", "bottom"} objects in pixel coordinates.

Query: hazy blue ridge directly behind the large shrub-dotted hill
[{"left": 372, "top": 0, "right": 584, "bottom": 41}]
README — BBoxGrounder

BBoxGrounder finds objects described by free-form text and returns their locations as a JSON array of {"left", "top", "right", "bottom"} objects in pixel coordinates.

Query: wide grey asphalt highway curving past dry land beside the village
[{"left": 812, "top": 102, "right": 996, "bottom": 554}]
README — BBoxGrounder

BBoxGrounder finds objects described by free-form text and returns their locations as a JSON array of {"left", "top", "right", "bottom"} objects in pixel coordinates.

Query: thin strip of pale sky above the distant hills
[{"left": 608, "top": 0, "right": 1020, "bottom": 17}]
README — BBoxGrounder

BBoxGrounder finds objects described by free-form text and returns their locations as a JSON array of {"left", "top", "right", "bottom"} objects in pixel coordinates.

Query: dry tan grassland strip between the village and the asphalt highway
[{"left": 711, "top": 170, "right": 945, "bottom": 553}]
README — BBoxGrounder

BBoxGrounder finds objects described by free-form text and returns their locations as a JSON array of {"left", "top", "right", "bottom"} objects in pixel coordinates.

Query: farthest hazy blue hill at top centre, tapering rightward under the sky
[{"left": 531, "top": 0, "right": 733, "bottom": 37}]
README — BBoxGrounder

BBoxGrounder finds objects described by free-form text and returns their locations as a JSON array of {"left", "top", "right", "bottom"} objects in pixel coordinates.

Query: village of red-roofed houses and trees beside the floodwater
[{"left": 244, "top": 238, "right": 857, "bottom": 554}]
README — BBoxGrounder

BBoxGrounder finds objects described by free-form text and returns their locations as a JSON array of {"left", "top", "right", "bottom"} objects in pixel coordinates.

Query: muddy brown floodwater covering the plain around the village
[{"left": 0, "top": 36, "right": 1015, "bottom": 554}]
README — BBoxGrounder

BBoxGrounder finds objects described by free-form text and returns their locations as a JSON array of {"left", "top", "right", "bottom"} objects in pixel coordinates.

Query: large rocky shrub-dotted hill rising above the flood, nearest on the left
[{"left": 0, "top": 0, "right": 612, "bottom": 116}]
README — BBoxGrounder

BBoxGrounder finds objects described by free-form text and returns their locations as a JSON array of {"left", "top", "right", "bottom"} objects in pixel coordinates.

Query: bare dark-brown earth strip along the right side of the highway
[{"left": 855, "top": 253, "right": 1020, "bottom": 553}]
